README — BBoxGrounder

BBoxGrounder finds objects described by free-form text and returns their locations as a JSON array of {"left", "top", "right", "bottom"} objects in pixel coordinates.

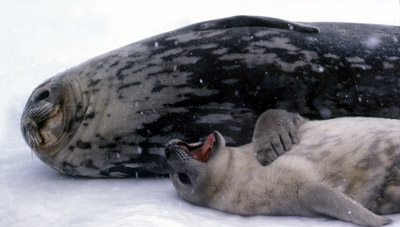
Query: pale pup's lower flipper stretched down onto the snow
[{"left": 298, "top": 184, "right": 391, "bottom": 226}]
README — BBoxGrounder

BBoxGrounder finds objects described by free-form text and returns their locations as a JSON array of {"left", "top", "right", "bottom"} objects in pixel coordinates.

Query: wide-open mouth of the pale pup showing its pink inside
[{"left": 169, "top": 133, "right": 218, "bottom": 162}]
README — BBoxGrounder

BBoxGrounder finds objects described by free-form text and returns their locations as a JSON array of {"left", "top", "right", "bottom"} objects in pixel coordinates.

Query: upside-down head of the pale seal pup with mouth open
[{"left": 165, "top": 131, "right": 226, "bottom": 205}]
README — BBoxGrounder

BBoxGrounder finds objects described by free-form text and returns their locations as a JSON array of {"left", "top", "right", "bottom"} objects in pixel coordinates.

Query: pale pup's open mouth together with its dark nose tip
[{"left": 165, "top": 132, "right": 220, "bottom": 162}]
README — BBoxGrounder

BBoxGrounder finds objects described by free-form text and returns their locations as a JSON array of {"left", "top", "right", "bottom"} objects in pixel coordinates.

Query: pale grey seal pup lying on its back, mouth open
[{"left": 165, "top": 110, "right": 400, "bottom": 226}]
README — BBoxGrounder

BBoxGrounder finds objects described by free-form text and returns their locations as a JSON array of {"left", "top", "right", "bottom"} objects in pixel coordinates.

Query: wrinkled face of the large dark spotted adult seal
[{"left": 21, "top": 76, "right": 86, "bottom": 166}]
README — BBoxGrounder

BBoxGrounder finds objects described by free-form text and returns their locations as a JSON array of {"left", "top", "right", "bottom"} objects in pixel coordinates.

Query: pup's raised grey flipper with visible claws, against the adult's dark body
[{"left": 253, "top": 109, "right": 306, "bottom": 165}]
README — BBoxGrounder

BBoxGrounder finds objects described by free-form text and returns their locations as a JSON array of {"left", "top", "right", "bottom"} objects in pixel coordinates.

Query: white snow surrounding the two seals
[{"left": 0, "top": 0, "right": 400, "bottom": 227}]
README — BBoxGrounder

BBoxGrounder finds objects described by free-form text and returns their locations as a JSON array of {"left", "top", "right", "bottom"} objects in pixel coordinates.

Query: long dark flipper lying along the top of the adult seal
[{"left": 184, "top": 16, "right": 319, "bottom": 33}]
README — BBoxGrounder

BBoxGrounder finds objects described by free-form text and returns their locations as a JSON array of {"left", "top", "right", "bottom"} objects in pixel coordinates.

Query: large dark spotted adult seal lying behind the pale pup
[{"left": 21, "top": 16, "right": 400, "bottom": 177}]
